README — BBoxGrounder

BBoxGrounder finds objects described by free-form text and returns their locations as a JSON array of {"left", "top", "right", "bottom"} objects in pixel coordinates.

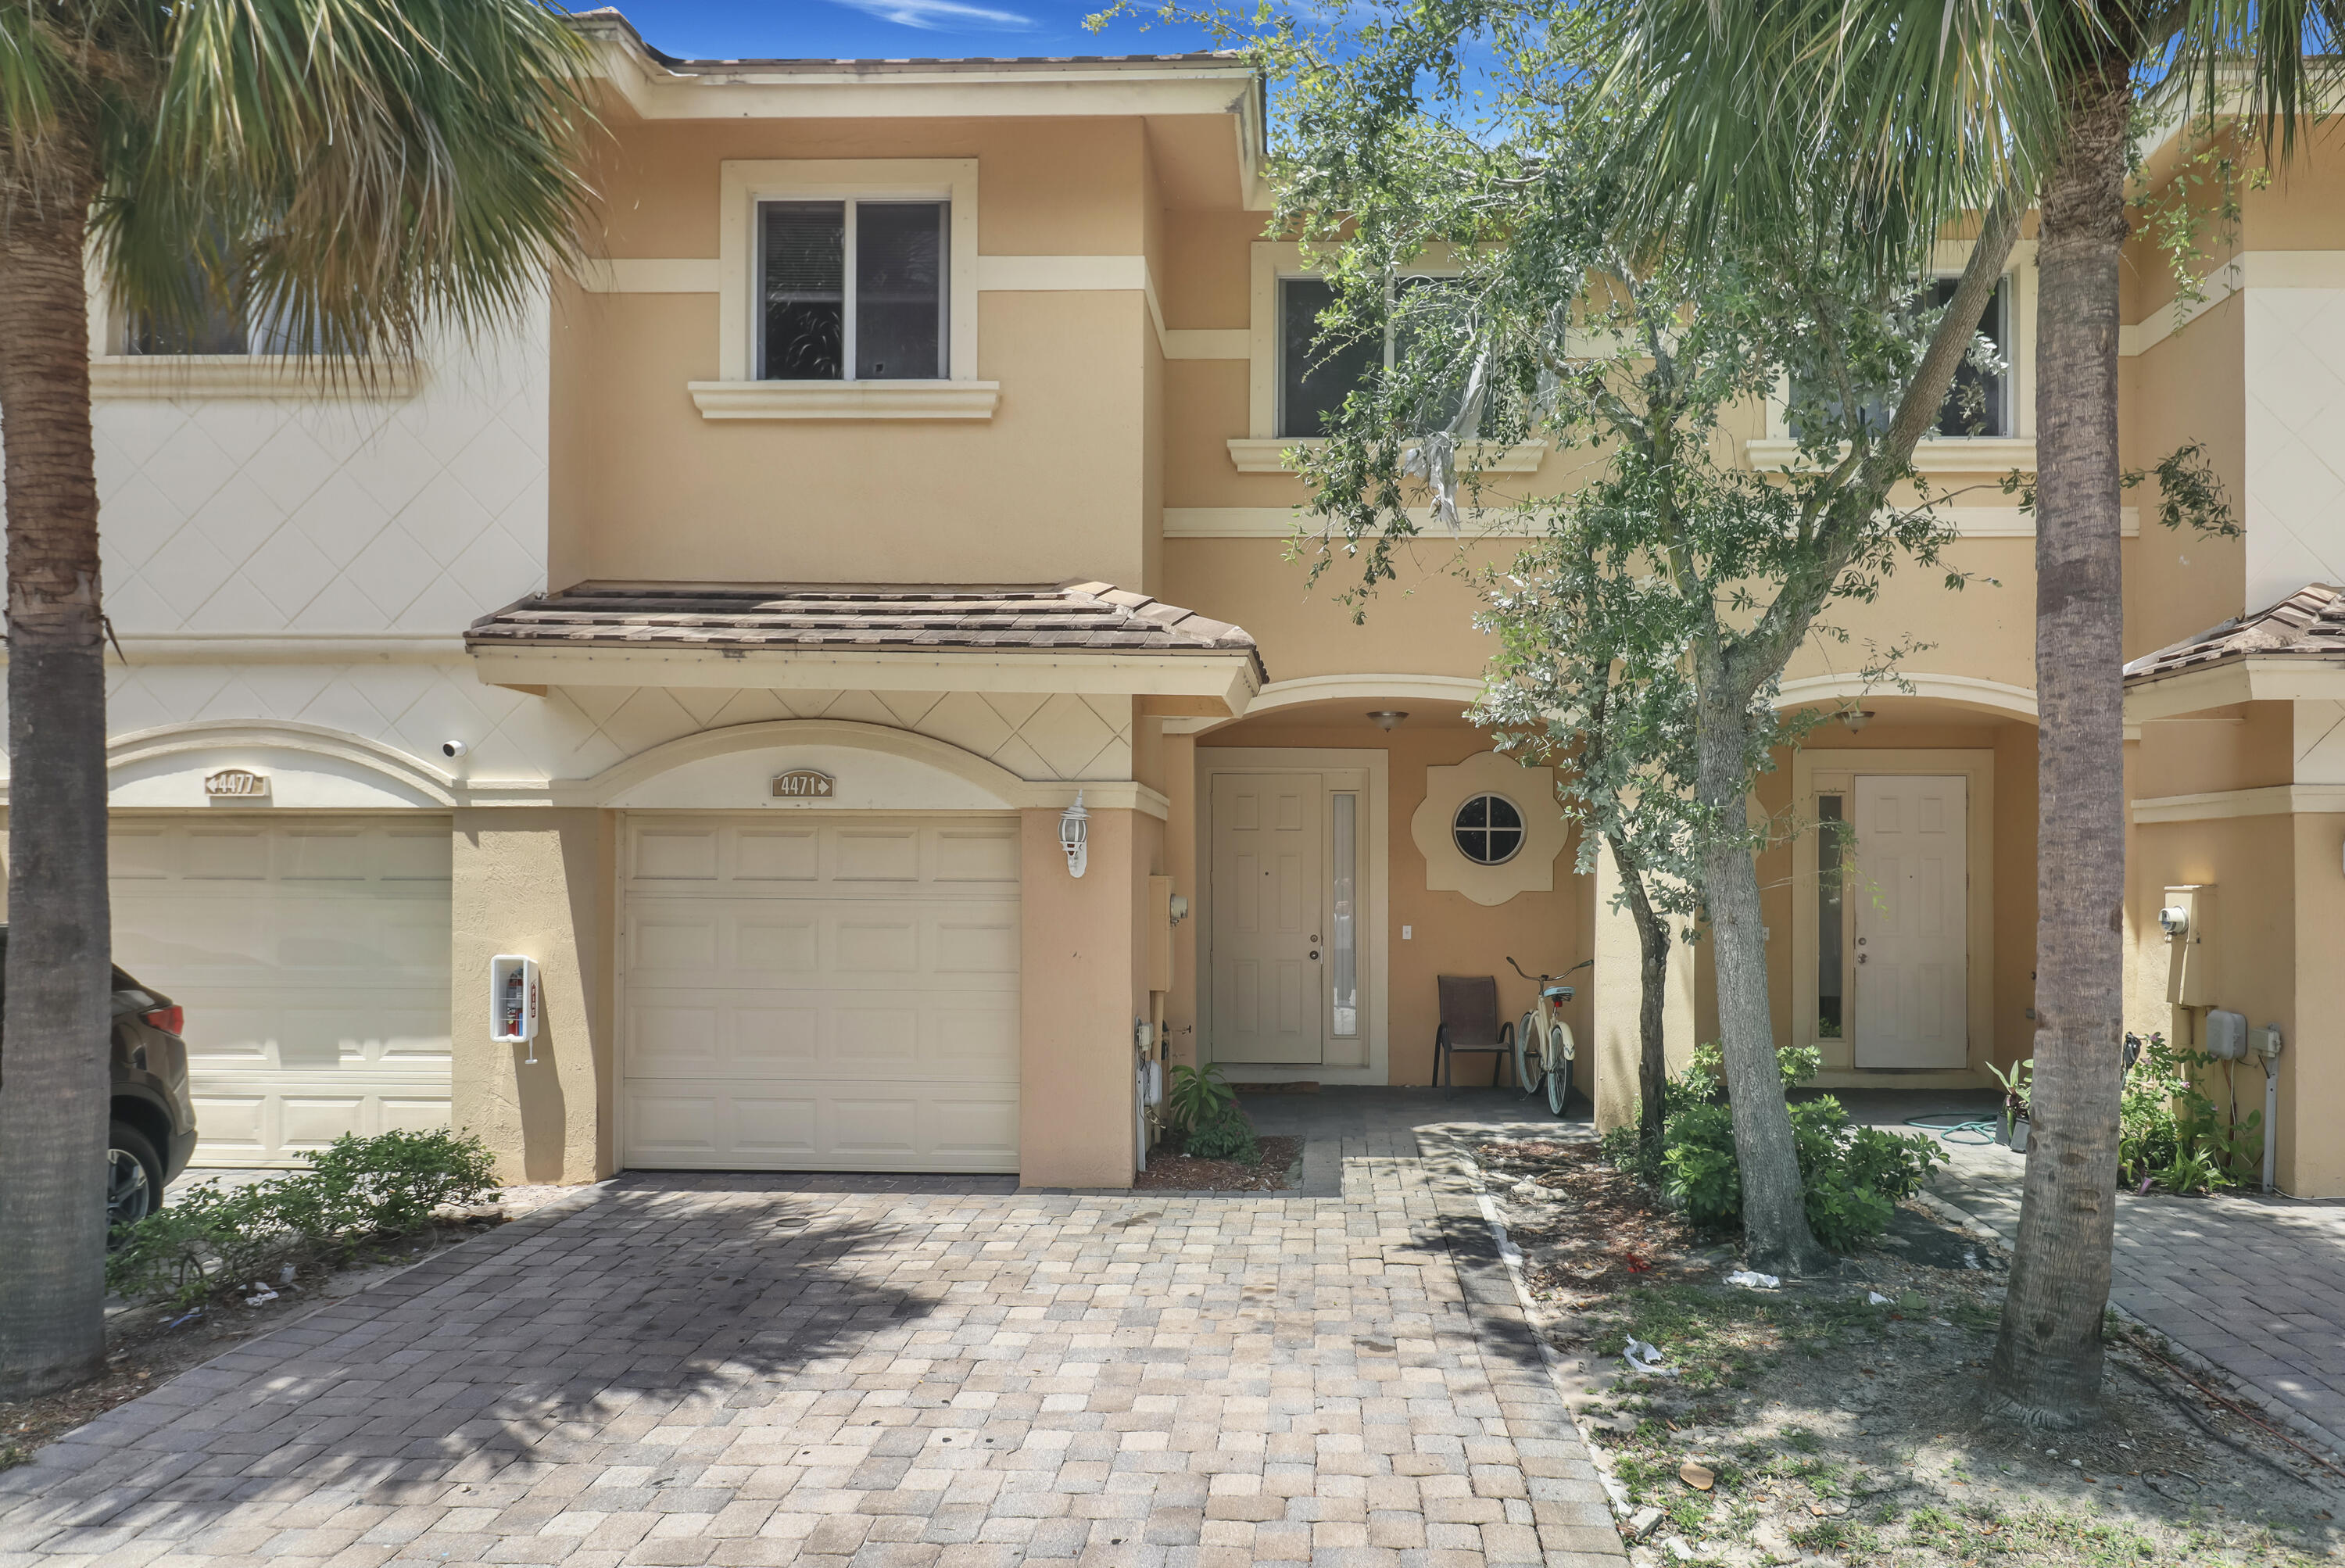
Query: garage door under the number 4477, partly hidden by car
[{"left": 110, "top": 815, "right": 450, "bottom": 1165}]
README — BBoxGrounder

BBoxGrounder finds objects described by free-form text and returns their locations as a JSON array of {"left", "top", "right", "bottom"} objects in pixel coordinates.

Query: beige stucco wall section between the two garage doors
[{"left": 450, "top": 808, "right": 617, "bottom": 1181}]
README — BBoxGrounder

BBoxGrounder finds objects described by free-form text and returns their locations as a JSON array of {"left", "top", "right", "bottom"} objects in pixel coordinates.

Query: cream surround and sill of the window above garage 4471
[{"left": 704, "top": 157, "right": 980, "bottom": 420}]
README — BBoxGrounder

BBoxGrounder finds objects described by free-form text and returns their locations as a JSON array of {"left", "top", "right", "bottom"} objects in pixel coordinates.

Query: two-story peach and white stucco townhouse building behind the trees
[{"left": 18, "top": 12, "right": 2345, "bottom": 1190}]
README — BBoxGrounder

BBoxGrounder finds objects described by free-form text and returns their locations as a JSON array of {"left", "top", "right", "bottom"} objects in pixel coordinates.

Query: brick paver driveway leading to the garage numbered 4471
[{"left": 0, "top": 1158, "right": 1620, "bottom": 1568}]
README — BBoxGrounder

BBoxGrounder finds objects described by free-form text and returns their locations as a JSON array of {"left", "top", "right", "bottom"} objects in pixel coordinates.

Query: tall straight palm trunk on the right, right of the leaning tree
[{"left": 1991, "top": 59, "right": 2132, "bottom": 1425}]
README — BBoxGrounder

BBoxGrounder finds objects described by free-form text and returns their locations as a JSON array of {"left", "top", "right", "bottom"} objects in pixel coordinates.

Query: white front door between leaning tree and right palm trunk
[{"left": 1848, "top": 776, "right": 1970, "bottom": 1066}]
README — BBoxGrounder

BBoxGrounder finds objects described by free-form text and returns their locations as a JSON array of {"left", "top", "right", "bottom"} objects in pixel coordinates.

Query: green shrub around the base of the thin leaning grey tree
[{"left": 1606, "top": 1045, "right": 1946, "bottom": 1251}]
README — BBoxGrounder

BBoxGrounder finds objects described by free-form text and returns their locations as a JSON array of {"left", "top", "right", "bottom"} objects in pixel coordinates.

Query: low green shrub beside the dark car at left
[{"left": 106, "top": 1132, "right": 497, "bottom": 1305}]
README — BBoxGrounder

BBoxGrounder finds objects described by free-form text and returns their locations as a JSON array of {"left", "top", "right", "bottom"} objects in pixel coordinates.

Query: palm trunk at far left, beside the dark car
[{"left": 0, "top": 192, "right": 110, "bottom": 1399}]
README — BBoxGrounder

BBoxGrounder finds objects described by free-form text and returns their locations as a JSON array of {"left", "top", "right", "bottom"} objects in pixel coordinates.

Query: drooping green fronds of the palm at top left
[{"left": 96, "top": 0, "right": 596, "bottom": 366}]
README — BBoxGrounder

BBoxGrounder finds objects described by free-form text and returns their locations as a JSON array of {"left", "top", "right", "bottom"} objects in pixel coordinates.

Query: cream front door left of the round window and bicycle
[{"left": 1210, "top": 774, "right": 1327, "bottom": 1064}]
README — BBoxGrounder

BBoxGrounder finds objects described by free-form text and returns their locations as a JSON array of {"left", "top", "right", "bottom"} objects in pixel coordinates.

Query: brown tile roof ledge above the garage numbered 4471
[{"left": 464, "top": 582, "right": 1269, "bottom": 680}]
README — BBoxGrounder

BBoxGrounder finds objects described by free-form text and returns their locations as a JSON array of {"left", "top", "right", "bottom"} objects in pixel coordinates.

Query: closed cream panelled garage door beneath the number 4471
[{"left": 621, "top": 815, "right": 1018, "bottom": 1172}]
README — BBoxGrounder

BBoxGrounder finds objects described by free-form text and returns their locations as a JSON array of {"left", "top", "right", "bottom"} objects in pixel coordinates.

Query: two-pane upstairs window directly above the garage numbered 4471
[{"left": 757, "top": 199, "right": 952, "bottom": 382}]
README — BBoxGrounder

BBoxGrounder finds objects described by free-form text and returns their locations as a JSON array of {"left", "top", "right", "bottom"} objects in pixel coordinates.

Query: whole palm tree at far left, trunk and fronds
[{"left": 0, "top": 0, "right": 593, "bottom": 1399}]
